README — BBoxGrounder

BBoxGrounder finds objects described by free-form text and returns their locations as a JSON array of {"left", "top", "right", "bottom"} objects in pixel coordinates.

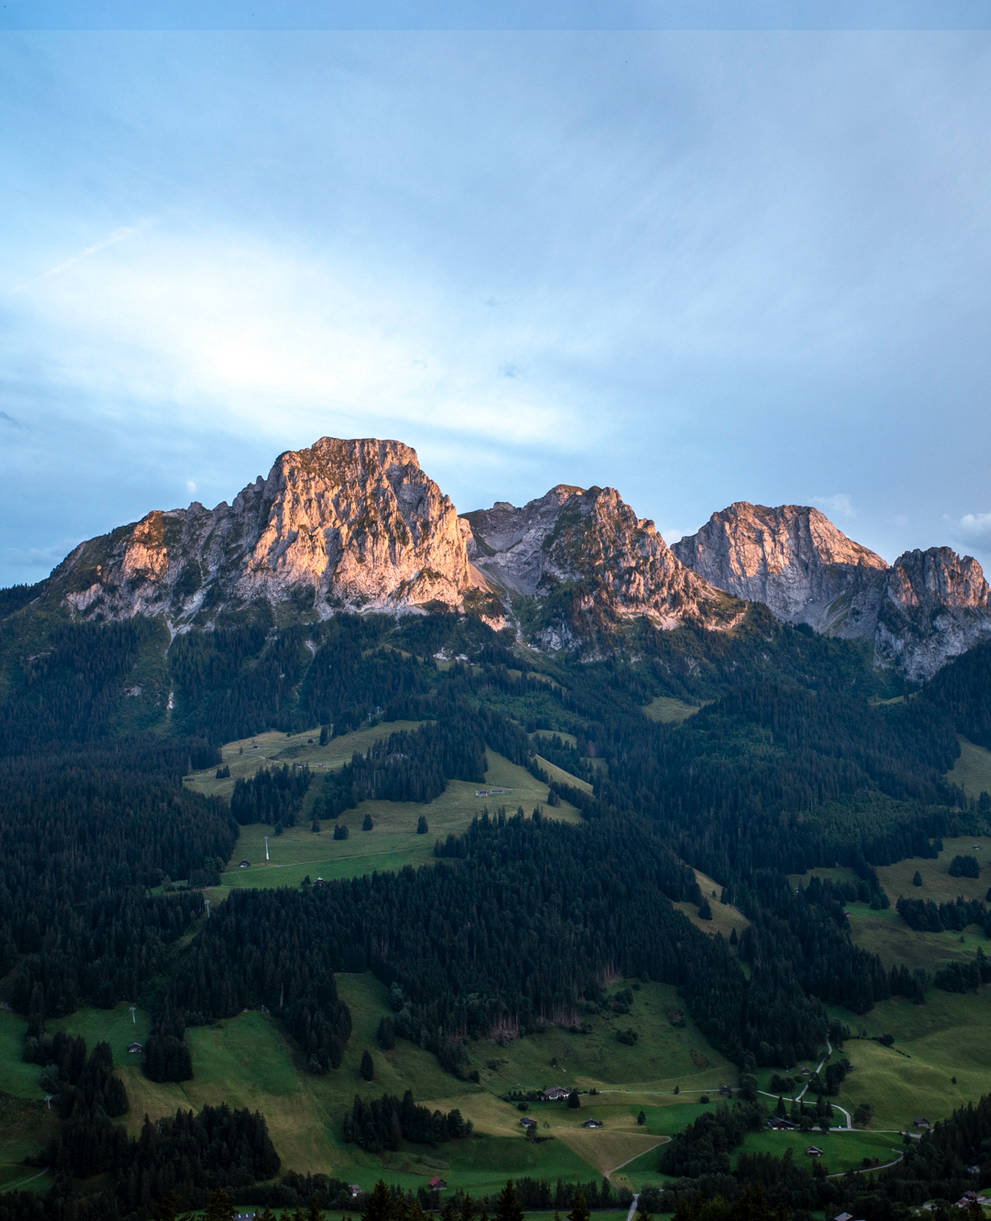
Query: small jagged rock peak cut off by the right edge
[{"left": 875, "top": 547, "right": 991, "bottom": 681}]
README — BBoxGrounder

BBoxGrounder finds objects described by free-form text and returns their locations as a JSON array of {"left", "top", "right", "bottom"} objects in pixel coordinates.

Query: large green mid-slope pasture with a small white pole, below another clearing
[{"left": 214, "top": 751, "right": 581, "bottom": 894}]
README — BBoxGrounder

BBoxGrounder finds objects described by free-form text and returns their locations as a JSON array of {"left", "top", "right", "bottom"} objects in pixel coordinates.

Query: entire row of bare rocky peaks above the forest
[{"left": 21, "top": 437, "right": 991, "bottom": 681}]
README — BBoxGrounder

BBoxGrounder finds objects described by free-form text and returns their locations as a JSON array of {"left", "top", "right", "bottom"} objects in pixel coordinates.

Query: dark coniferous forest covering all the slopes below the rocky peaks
[{"left": 0, "top": 595, "right": 991, "bottom": 1221}]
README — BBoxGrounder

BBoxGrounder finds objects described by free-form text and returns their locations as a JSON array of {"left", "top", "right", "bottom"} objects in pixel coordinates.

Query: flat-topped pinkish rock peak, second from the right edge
[{"left": 672, "top": 501, "right": 887, "bottom": 637}]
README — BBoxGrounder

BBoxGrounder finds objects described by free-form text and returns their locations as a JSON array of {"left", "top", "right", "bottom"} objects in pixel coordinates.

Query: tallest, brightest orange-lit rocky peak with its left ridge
[{"left": 50, "top": 437, "right": 477, "bottom": 624}]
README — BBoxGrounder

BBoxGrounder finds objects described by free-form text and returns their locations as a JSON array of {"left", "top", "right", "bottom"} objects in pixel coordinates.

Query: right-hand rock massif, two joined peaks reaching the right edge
[{"left": 672, "top": 502, "right": 991, "bottom": 681}]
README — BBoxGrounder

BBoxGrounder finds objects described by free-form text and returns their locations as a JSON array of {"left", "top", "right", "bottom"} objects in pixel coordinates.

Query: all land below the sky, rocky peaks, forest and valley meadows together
[{"left": 0, "top": 438, "right": 991, "bottom": 1221}]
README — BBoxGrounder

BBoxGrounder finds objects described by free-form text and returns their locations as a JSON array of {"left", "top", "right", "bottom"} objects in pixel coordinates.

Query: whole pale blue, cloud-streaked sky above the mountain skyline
[{"left": 0, "top": 0, "right": 991, "bottom": 584}]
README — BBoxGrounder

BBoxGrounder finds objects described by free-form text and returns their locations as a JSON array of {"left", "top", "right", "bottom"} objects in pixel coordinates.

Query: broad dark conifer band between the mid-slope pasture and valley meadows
[{"left": 165, "top": 817, "right": 826, "bottom": 1062}]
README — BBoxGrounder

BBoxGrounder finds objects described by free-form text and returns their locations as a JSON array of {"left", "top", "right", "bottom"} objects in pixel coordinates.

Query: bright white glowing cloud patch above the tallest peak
[{"left": 5, "top": 226, "right": 593, "bottom": 451}]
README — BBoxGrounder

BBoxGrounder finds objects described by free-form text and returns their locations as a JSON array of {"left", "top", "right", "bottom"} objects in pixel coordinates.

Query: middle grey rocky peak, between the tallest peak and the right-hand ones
[{"left": 465, "top": 484, "right": 743, "bottom": 643}]
